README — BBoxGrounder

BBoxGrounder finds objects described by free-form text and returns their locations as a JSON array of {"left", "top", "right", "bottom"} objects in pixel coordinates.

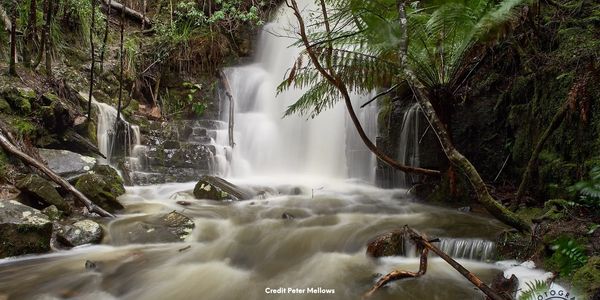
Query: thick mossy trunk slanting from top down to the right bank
[{"left": 397, "top": 0, "right": 531, "bottom": 232}]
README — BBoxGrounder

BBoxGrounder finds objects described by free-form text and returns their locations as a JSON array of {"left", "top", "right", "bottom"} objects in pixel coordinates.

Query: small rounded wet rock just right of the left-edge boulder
[{"left": 56, "top": 220, "right": 103, "bottom": 247}]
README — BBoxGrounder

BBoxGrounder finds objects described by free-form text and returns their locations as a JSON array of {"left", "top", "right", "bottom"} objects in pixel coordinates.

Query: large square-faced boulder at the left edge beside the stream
[{"left": 0, "top": 200, "right": 52, "bottom": 258}]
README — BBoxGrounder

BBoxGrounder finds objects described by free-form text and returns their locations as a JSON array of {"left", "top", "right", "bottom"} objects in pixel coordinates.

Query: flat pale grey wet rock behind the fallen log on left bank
[{"left": 38, "top": 149, "right": 96, "bottom": 180}]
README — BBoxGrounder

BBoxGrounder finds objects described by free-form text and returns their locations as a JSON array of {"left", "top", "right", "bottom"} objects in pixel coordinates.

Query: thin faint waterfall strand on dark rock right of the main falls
[{"left": 397, "top": 103, "right": 423, "bottom": 186}]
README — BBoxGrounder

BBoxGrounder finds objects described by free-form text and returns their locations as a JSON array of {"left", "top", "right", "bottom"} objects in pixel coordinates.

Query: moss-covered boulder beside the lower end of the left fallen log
[{"left": 75, "top": 169, "right": 125, "bottom": 213}]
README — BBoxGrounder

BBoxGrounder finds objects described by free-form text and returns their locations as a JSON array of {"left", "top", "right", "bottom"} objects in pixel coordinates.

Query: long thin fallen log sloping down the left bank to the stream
[{"left": 0, "top": 128, "right": 115, "bottom": 218}]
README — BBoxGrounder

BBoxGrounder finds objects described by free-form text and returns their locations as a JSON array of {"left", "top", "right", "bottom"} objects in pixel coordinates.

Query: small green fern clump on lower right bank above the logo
[{"left": 551, "top": 237, "right": 588, "bottom": 277}]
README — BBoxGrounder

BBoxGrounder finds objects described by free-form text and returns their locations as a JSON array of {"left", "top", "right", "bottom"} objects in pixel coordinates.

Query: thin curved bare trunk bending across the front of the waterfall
[{"left": 286, "top": 0, "right": 440, "bottom": 176}]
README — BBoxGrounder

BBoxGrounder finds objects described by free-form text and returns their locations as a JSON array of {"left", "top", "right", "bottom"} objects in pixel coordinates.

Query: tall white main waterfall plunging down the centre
[{"left": 222, "top": 1, "right": 377, "bottom": 181}]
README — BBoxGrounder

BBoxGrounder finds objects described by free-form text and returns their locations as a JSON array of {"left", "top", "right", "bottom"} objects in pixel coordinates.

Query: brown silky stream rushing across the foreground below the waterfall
[{"left": 0, "top": 178, "right": 516, "bottom": 299}]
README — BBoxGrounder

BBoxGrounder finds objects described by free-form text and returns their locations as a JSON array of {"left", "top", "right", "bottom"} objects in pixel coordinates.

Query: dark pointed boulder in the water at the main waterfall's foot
[{"left": 194, "top": 176, "right": 252, "bottom": 201}]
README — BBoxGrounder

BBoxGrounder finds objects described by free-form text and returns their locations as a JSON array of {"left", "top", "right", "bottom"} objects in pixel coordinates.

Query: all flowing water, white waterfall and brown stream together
[{"left": 0, "top": 1, "right": 548, "bottom": 300}]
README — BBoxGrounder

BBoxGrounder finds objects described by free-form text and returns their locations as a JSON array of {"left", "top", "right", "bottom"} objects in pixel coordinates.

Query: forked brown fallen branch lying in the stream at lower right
[{"left": 363, "top": 225, "right": 511, "bottom": 300}]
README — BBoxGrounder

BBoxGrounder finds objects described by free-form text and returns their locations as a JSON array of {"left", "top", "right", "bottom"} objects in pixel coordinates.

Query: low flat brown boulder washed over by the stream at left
[{"left": 111, "top": 212, "right": 195, "bottom": 245}]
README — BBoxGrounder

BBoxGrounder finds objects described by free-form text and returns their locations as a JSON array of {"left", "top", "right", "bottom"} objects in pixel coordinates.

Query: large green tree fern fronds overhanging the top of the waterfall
[{"left": 279, "top": 0, "right": 530, "bottom": 116}]
